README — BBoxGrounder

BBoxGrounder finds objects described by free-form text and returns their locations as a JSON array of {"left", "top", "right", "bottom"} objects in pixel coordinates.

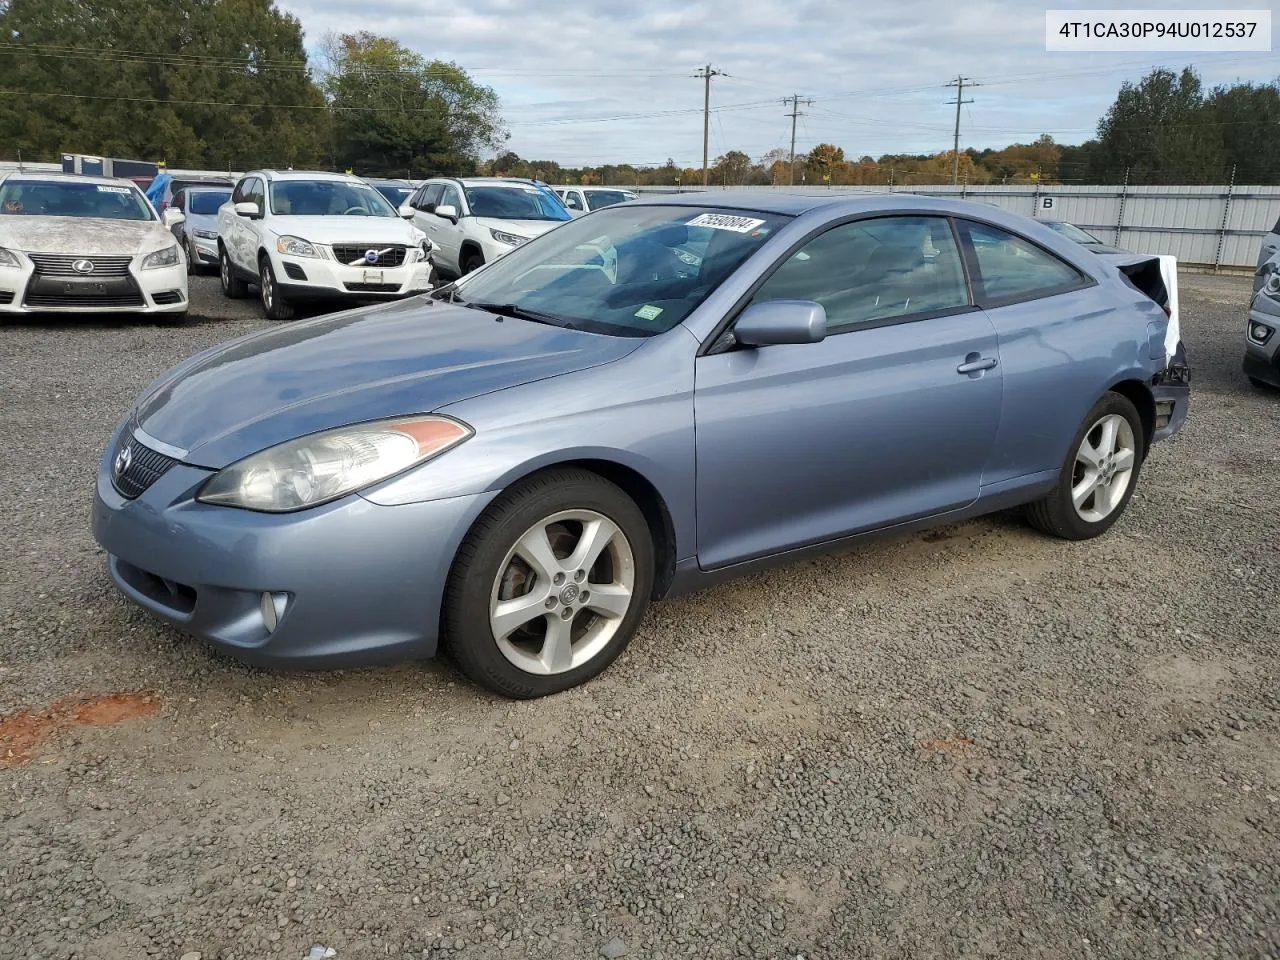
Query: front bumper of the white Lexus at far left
[{"left": 0, "top": 257, "right": 187, "bottom": 314}]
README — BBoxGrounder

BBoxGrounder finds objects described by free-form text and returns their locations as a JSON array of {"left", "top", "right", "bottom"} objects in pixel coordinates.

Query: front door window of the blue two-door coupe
[{"left": 754, "top": 216, "right": 969, "bottom": 333}]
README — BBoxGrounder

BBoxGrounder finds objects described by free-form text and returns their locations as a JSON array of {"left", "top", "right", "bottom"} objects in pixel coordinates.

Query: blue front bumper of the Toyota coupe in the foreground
[{"left": 92, "top": 430, "right": 493, "bottom": 669}]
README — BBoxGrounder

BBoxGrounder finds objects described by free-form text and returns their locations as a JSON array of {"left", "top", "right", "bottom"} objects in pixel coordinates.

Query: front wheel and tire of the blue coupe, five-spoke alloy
[{"left": 444, "top": 468, "right": 654, "bottom": 700}]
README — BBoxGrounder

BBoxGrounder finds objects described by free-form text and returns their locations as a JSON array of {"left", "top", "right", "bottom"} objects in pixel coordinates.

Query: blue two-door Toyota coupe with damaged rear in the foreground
[{"left": 93, "top": 192, "right": 1190, "bottom": 698}]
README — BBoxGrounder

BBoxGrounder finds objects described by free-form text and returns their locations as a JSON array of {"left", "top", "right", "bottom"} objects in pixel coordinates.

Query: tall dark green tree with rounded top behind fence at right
[{"left": 1091, "top": 67, "right": 1224, "bottom": 183}]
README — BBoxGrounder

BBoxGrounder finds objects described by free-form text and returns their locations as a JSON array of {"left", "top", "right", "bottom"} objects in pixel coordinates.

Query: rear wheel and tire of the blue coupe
[{"left": 1027, "top": 393, "right": 1146, "bottom": 540}]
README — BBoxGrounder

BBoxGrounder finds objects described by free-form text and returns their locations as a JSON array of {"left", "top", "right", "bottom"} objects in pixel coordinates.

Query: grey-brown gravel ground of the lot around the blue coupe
[{"left": 0, "top": 276, "right": 1280, "bottom": 960}]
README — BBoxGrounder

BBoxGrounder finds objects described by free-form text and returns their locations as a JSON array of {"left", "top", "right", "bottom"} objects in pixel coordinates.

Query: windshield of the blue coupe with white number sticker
[{"left": 457, "top": 205, "right": 790, "bottom": 337}]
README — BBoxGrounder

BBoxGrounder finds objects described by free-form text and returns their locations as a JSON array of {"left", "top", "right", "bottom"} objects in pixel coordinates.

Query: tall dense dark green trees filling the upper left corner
[{"left": 0, "top": 0, "right": 328, "bottom": 169}]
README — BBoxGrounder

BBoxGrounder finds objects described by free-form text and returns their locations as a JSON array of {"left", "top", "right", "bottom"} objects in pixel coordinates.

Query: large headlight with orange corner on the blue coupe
[{"left": 196, "top": 416, "right": 475, "bottom": 513}]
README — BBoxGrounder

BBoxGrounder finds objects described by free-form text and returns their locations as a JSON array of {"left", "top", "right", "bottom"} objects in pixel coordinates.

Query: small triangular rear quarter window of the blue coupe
[{"left": 957, "top": 220, "right": 1087, "bottom": 303}]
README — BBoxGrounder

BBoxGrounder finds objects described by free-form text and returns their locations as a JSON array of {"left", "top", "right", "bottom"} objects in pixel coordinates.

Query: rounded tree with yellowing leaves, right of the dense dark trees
[{"left": 314, "top": 31, "right": 504, "bottom": 177}]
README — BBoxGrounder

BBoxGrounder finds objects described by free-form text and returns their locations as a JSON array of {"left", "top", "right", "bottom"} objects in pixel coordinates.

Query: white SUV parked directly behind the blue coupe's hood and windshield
[{"left": 408, "top": 177, "right": 573, "bottom": 276}]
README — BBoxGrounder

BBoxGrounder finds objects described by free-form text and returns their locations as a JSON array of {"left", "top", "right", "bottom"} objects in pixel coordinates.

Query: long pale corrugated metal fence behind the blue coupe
[{"left": 631, "top": 184, "right": 1280, "bottom": 270}]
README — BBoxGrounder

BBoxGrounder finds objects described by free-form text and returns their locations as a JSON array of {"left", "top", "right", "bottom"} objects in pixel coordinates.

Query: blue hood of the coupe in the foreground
[{"left": 133, "top": 298, "right": 643, "bottom": 468}]
